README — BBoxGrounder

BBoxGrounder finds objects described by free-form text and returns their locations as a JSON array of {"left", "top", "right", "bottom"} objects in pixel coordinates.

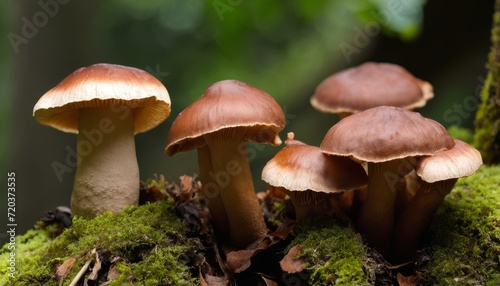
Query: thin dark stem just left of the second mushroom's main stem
[{"left": 198, "top": 145, "right": 229, "bottom": 240}]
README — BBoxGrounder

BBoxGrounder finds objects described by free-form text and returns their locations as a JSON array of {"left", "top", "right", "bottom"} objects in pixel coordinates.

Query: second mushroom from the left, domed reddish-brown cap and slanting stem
[{"left": 165, "top": 80, "right": 285, "bottom": 248}]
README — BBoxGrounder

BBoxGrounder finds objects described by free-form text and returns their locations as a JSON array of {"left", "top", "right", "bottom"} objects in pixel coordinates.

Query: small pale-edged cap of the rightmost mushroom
[{"left": 415, "top": 139, "right": 483, "bottom": 183}]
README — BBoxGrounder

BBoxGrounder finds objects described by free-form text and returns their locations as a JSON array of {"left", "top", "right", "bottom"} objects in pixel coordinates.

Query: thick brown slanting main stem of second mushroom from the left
[{"left": 207, "top": 136, "right": 267, "bottom": 248}]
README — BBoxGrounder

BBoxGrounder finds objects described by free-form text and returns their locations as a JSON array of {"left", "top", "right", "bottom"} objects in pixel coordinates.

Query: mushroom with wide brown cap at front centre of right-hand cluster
[{"left": 320, "top": 106, "right": 455, "bottom": 257}]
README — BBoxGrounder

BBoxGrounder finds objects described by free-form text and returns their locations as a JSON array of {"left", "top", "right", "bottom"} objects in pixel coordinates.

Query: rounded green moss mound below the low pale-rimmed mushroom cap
[{"left": 289, "top": 218, "right": 375, "bottom": 285}]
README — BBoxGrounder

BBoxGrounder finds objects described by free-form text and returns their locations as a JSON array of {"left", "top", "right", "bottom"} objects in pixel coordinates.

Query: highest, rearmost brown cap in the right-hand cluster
[{"left": 311, "top": 62, "right": 434, "bottom": 113}]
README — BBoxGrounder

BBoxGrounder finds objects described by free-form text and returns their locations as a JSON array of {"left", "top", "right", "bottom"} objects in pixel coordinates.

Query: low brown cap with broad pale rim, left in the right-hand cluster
[{"left": 262, "top": 135, "right": 368, "bottom": 193}]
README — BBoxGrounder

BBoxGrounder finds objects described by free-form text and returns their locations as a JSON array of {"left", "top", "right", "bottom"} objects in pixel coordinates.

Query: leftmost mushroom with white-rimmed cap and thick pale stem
[{"left": 33, "top": 64, "right": 170, "bottom": 218}]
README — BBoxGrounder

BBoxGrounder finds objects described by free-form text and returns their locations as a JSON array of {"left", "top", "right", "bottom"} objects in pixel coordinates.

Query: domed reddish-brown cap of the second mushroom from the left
[{"left": 165, "top": 80, "right": 285, "bottom": 156}]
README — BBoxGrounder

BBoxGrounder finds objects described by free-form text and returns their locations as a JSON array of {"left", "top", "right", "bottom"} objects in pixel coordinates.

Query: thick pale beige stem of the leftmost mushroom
[{"left": 71, "top": 108, "right": 139, "bottom": 218}]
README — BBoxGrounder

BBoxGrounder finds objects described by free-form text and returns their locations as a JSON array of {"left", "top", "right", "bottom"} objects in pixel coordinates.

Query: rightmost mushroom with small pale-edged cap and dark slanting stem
[{"left": 393, "top": 139, "right": 483, "bottom": 262}]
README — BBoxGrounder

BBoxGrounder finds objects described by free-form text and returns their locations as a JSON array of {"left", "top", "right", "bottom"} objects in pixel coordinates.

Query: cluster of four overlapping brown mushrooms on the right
[{"left": 262, "top": 62, "right": 482, "bottom": 262}]
